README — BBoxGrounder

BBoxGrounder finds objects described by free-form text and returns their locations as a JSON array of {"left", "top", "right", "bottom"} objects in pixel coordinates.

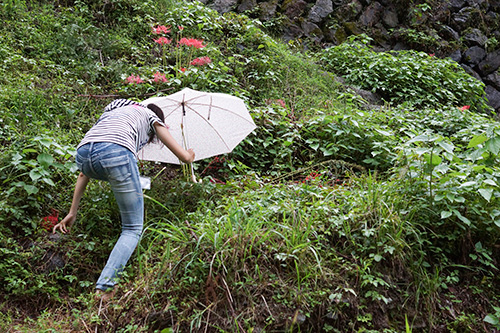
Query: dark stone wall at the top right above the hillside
[{"left": 202, "top": 0, "right": 500, "bottom": 113}]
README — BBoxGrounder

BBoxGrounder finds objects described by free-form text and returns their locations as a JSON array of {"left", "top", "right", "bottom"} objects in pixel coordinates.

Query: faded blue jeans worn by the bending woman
[{"left": 76, "top": 142, "right": 144, "bottom": 290}]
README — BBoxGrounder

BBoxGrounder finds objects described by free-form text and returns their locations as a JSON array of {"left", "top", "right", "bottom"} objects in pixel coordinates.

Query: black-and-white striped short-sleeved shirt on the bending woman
[{"left": 77, "top": 100, "right": 165, "bottom": 156}]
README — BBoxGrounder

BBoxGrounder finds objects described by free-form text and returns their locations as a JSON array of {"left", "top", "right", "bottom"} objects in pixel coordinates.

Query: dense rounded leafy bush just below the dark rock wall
[{"left": 321, "top": 37, "right": 489, "bottom": 112}]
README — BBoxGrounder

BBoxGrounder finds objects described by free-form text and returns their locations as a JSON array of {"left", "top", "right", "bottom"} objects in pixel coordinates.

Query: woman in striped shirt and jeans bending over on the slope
[{"left": 53, "top": 99, "right": 195, "bottom": 300}]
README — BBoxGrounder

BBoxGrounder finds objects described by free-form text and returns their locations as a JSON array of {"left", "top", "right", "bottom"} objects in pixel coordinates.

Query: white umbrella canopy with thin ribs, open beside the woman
[{"left": 138, "top": 88, "right": 256, "bottom": 164}]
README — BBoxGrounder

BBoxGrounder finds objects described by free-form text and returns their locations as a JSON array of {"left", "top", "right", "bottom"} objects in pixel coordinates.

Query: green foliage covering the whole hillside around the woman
[{"left": 0, "top": 0, "right": 500, "bottom": 332}]
